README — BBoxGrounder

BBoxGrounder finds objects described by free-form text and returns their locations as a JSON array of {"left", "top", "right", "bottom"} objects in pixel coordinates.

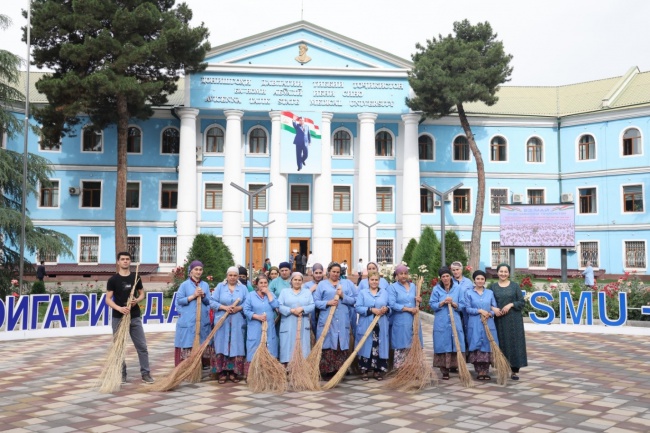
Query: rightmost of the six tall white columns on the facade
[{"left": 396, "top": 113, "right": 421, "bottom": 257}]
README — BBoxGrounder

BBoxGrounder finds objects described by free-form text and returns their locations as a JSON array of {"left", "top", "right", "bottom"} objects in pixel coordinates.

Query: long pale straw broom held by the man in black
[{"left": 93, "top": 265, "right": 140, "bottom": 394}]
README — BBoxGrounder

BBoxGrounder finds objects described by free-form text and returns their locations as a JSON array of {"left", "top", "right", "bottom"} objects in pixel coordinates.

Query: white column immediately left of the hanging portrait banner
[{"left": 268, "top": 111, "right": 289, "bottom": 266}]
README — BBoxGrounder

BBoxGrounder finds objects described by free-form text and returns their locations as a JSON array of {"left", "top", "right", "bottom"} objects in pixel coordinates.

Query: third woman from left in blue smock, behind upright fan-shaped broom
[{"left": 243, "top": 274, "right": 278, "bottom": 376}]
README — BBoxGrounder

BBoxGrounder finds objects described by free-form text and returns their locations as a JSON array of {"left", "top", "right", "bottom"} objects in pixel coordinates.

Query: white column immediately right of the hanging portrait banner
[{"left": 311, "top": 113, "right": 333, "bottom": 266}]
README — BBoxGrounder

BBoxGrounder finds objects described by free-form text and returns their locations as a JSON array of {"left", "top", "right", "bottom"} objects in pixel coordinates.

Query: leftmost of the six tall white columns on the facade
[{"left": 176, "top": 108, "right": 199, "bottom": 266}]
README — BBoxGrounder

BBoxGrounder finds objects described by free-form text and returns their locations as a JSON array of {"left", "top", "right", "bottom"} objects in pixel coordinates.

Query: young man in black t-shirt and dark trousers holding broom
[{"left": 106, "top": 252, "right": 154, "bottom": 384}]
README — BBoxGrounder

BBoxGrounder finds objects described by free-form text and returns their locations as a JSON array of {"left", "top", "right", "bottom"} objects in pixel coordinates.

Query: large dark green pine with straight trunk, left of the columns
[{"left": 31, "top": 0, "right": 210, "bottom": 252}]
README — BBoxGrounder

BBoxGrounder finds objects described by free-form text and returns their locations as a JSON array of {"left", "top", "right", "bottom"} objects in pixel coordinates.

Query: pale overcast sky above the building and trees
[{"left": 0, "top": 0, "right": 650, "bottom": 86}]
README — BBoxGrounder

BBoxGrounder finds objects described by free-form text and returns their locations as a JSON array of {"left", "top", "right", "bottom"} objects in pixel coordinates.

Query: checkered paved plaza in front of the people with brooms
[{"left": 0, "top": 325, "right": 650, "bottom": 433}]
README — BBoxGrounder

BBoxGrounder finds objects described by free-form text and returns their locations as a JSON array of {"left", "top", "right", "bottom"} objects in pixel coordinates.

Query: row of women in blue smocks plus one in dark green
[{"left": 175, "top": 261, "right": 526, "bottom": 383}]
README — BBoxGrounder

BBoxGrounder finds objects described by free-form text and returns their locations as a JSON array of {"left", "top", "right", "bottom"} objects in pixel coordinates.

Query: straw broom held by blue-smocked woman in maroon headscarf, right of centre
[{"left": 387, "top": 277, "right": 437, "bottom": 391}]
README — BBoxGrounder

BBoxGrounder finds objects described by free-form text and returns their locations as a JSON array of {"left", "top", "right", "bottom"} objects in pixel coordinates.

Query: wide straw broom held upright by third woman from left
[{"left": 246, "top": 321, "right": 287, "bottom": 394}]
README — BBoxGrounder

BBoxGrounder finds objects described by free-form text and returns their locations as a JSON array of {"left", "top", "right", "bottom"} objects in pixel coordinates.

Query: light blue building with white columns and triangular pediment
[{"left": 3, "top": 21, "right": 650, "bottom": 274}]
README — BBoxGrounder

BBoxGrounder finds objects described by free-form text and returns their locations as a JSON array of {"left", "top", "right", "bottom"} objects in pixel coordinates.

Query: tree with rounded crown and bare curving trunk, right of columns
[{"left": 406, "top": 20, "right": 512, "bottom": 269}]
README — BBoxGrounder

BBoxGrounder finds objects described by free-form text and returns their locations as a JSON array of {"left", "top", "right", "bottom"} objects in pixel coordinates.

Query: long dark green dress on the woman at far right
[{"left": 490, "top": 281, "right": 528, "bottom": 368}]
